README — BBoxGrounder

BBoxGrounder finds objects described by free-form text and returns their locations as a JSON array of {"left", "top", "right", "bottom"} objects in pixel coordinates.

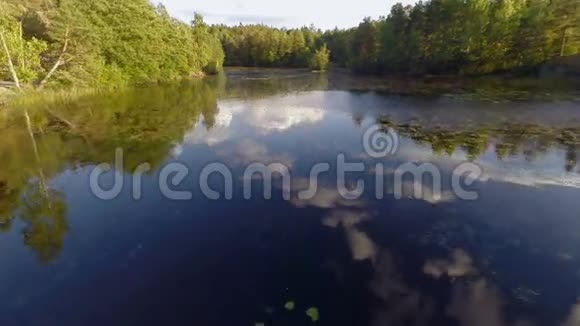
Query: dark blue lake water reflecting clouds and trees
[{"left": 0, "top": 71, "right": 580, "bottom": 326}]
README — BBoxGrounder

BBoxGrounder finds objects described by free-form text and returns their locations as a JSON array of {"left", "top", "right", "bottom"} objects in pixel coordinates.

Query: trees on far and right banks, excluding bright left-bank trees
[{"left": 206, "top": 0, "right": 580, "bottom": 75}]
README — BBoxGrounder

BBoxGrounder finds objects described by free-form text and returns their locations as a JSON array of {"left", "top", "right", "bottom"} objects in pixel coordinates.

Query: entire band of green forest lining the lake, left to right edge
[{"left": 0, "top": 0, "right": 580, "bottom": 88}]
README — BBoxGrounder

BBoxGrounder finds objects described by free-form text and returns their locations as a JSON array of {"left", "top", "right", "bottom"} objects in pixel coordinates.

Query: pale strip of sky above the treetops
[{"left": 160, "top": 0, "right": 415, "bottom": 29}]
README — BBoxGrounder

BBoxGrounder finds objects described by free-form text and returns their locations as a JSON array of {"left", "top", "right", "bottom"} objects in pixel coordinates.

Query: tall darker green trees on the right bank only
[{"left": 330, "top": 0, "right": 580, "bottom": 74}]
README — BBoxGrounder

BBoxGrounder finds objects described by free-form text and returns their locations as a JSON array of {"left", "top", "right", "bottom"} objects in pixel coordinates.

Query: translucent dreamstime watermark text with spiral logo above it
[{"left": 89, "top": 125, "right": 483, "bottom": 202}]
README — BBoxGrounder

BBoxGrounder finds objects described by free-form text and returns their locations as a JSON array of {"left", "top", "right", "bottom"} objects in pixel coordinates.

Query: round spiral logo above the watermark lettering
[{"left": 363, "top": 125, "right": 399, "bottom": 158}]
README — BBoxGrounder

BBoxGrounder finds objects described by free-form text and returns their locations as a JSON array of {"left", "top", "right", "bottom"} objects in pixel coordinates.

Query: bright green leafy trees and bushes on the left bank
[{"left": 0, "top": 0, "right": 224, "bottom": 88}]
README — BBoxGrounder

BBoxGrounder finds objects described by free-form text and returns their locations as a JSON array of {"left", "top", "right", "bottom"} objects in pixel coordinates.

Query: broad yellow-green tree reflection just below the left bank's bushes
[{"left": 40, "top": 81, "right": 218, "bottom": 171}]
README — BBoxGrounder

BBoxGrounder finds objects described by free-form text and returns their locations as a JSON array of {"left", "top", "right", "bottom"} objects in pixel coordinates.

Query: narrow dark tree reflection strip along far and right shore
[{"left": 218, "top": 68, "right": 579, "bottom": 102}]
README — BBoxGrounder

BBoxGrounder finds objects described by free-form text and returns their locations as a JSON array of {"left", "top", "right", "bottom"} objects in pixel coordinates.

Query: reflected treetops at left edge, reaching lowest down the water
[{"left": 0, "top": 126, "right": 68, "bottom": 262}]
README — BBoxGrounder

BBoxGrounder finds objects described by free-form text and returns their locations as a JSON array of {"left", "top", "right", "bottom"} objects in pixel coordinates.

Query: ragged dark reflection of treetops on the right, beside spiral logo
[{"left": 379, "top": 117, "right": 580, "bottom": 172}]
